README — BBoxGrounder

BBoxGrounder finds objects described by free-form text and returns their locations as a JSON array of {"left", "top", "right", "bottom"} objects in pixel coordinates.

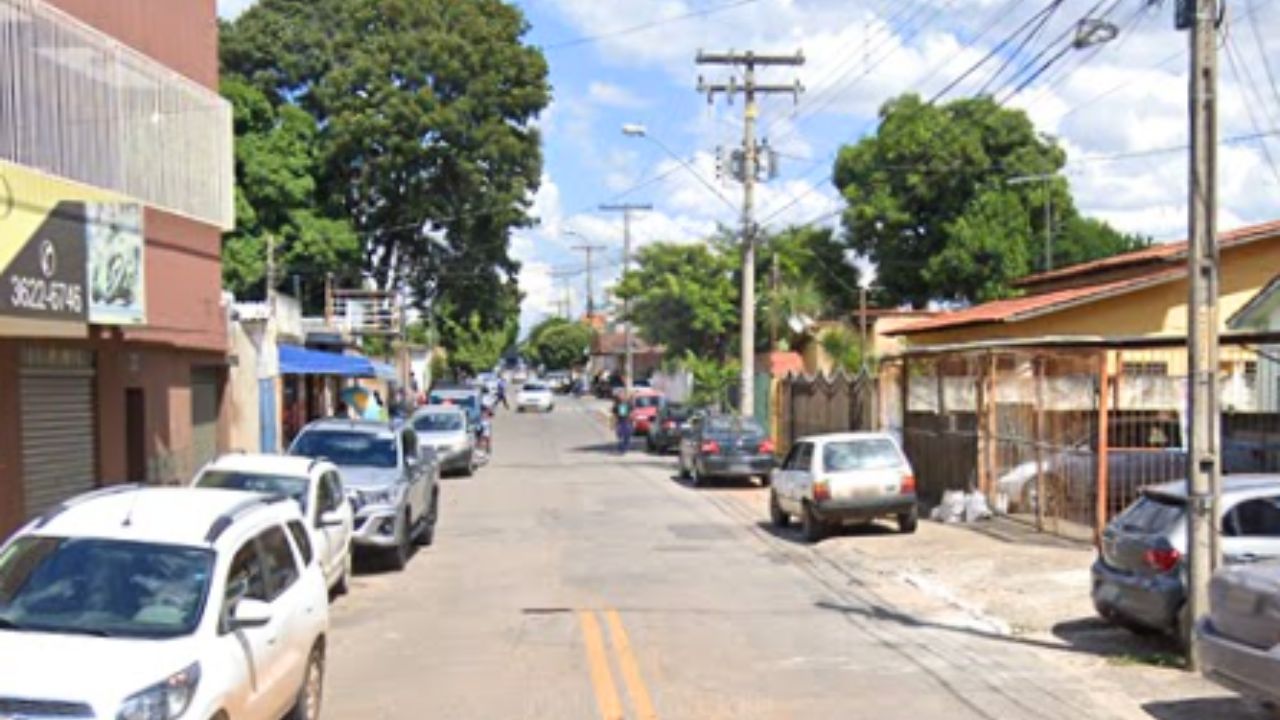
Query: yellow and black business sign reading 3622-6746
[{"left": 0, "top": 161, "right": 146, "bottom": 325}]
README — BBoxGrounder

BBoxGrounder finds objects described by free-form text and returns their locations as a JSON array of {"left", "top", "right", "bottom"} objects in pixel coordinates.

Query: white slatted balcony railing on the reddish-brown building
[{"left": 0, "top": 0, "right": 236, "bottom": 229}]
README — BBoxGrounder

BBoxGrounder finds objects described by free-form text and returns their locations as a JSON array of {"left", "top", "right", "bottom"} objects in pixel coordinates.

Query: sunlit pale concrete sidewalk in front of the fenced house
[{"left": 735, "top": 491, "right": 1274, "bottom": 720}]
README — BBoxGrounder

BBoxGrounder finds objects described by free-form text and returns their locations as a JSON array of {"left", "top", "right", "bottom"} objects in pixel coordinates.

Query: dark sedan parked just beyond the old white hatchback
[{"left": 680, "top": 415, "right": 774, "bottom": 487}]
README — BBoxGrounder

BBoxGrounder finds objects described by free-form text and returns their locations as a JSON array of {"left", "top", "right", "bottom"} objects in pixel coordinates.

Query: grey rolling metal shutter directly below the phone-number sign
[{"left": 19, "top": 354, "right": 97, "bottom": 516}]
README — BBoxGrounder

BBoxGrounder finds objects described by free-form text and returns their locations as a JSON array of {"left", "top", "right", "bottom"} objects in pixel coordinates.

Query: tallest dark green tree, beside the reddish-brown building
[{"left": 221, "top": 0, "right": 549, "bottom": 338}]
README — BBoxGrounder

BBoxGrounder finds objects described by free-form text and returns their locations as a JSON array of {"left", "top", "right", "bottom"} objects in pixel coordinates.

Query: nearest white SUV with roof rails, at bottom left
[{"left": 0, "top": 486, "right": 329, "bottom": 720}]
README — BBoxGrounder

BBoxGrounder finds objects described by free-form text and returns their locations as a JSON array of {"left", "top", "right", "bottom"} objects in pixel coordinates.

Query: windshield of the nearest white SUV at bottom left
[{"left": 0, "top": 537, "right": 214, "bottom": 639}]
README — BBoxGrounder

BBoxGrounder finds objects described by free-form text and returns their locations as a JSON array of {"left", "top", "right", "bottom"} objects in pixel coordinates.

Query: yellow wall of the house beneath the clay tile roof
[{"left": 906, "top": 237, "right": 1280, "bottom": 346}]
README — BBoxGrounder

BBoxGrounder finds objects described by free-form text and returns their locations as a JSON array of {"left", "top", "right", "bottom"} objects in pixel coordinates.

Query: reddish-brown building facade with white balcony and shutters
[{"left": 0, "top": 0, "right": 234, "bottom": 536}]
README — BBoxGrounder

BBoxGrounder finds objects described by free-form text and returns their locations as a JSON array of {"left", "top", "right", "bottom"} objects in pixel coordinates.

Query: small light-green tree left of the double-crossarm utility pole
[{"left": 614, "top": 238, "right": 739, "bottom": 359}]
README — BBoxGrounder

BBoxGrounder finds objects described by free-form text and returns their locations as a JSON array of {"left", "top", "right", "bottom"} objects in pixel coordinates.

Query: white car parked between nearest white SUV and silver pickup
[{"left": 191, "top": 452, "right": 355, "bottom": 594}]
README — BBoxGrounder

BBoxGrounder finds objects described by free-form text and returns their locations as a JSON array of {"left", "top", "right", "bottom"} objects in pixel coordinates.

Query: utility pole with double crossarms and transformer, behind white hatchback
[{"left": 696, "top": 50, "right": 804, "bottom": 418}]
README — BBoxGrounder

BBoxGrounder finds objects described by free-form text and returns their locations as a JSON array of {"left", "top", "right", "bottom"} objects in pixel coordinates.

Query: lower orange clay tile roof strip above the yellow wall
[{"left": 886, "top": 268, "right": 1185, "bottom": 334}]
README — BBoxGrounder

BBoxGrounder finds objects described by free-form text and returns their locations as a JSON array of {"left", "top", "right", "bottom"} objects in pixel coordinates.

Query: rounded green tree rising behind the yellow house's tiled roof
[{"left": 833, "top": 95, "right": 1142, "bottom": 306}]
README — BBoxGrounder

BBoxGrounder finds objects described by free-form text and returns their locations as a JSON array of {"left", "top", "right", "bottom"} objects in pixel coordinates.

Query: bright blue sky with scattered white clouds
[{"left": 219, "top": 0, "right": 1280, "bottom": 328}]
